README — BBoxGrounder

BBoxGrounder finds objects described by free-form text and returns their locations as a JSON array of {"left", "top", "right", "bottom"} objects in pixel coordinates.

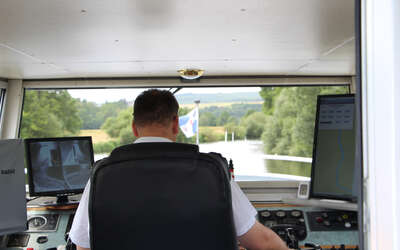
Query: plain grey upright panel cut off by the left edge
[{"left": 0, "top": 139, "right": 27, "bottom": 235}]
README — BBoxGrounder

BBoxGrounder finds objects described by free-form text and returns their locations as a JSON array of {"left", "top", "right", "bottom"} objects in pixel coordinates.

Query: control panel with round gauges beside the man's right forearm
[{"left": 257, "top": 204, "right": 359, "bottom": 250}]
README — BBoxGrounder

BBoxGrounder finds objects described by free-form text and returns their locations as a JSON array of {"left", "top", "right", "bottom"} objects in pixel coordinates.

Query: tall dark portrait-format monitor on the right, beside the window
[{"left": 310, "top": 94, "right": 358, "bottom": 202}]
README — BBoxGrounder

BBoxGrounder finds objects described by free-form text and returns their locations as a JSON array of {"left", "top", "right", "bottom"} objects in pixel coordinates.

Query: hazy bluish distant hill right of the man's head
[{"left": 175, "top": 92, "right": 263, "bottom": 104}]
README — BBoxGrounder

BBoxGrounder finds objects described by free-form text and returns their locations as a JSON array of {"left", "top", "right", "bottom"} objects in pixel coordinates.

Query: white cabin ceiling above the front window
[{"left": 0, "top": 0, "right": 355, "bottom": 79}]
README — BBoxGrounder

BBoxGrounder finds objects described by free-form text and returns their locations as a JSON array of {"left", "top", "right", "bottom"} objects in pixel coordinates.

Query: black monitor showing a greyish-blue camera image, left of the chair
[{"left": 25, "top": 137, "right": 94, "bottom": 204}]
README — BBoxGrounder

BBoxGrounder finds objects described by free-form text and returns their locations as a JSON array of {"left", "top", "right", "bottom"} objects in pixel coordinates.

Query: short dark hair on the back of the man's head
[{"left": 133, "top": 89, "right": 179, "bottom": 126}]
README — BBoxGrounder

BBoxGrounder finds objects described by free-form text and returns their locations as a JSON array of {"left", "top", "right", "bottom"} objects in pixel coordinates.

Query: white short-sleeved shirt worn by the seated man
[{"left": 69, "top": 137, "right": 257, "bottom": 248}]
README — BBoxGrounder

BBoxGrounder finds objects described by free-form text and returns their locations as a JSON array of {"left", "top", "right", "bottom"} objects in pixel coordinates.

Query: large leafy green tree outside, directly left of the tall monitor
[{"left": 260, "top": 87, "right": 348, "bottom": 157}]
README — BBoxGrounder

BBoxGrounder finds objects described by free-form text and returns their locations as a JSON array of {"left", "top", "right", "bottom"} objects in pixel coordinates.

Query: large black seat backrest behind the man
[{"left": 89, "top": 143, "right": 237, "bottom": 250}]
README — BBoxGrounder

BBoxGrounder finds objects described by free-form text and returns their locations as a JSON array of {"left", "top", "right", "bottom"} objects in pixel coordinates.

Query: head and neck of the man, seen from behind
[{"left": 132, "top": 89, "right": 179, "bottom": 141}]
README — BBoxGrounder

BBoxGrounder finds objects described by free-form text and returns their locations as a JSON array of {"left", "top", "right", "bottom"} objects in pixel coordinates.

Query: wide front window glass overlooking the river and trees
[{"left": 20, "top": 86, "right": 349, "bottom": 181}]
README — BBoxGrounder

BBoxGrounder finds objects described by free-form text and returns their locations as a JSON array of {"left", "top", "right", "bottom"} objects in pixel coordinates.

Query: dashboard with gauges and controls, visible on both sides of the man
[{"left": 4, "top": 203, "right": 358, "bottom": 250}]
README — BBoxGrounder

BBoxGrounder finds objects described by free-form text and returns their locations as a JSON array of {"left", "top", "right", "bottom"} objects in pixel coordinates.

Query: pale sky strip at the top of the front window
[{"left": 68, "top": 87, "right": 260, "bottom": 104}]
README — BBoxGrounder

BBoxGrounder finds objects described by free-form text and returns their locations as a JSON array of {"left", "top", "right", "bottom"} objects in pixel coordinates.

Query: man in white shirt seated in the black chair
[{"left": 70, "top": 89, "right": 288, "bottom": 250}]
